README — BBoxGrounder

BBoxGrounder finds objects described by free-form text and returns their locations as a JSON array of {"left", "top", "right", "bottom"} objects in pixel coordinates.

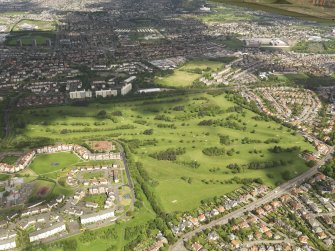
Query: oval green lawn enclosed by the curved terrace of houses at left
[{"left": 29, "top": 152, "right": 81, "bottom": 175}]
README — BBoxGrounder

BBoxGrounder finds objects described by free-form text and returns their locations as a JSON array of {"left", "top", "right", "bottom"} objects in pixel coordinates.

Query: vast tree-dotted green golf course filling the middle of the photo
[{"left": 17, "top": 91, "right": 312, "bottom": 212}]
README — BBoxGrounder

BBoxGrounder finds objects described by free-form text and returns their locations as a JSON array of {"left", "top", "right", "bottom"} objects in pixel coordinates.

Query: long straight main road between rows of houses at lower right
[{"left": 169, "top": 147, "right": 334, "bottom": 251}]
